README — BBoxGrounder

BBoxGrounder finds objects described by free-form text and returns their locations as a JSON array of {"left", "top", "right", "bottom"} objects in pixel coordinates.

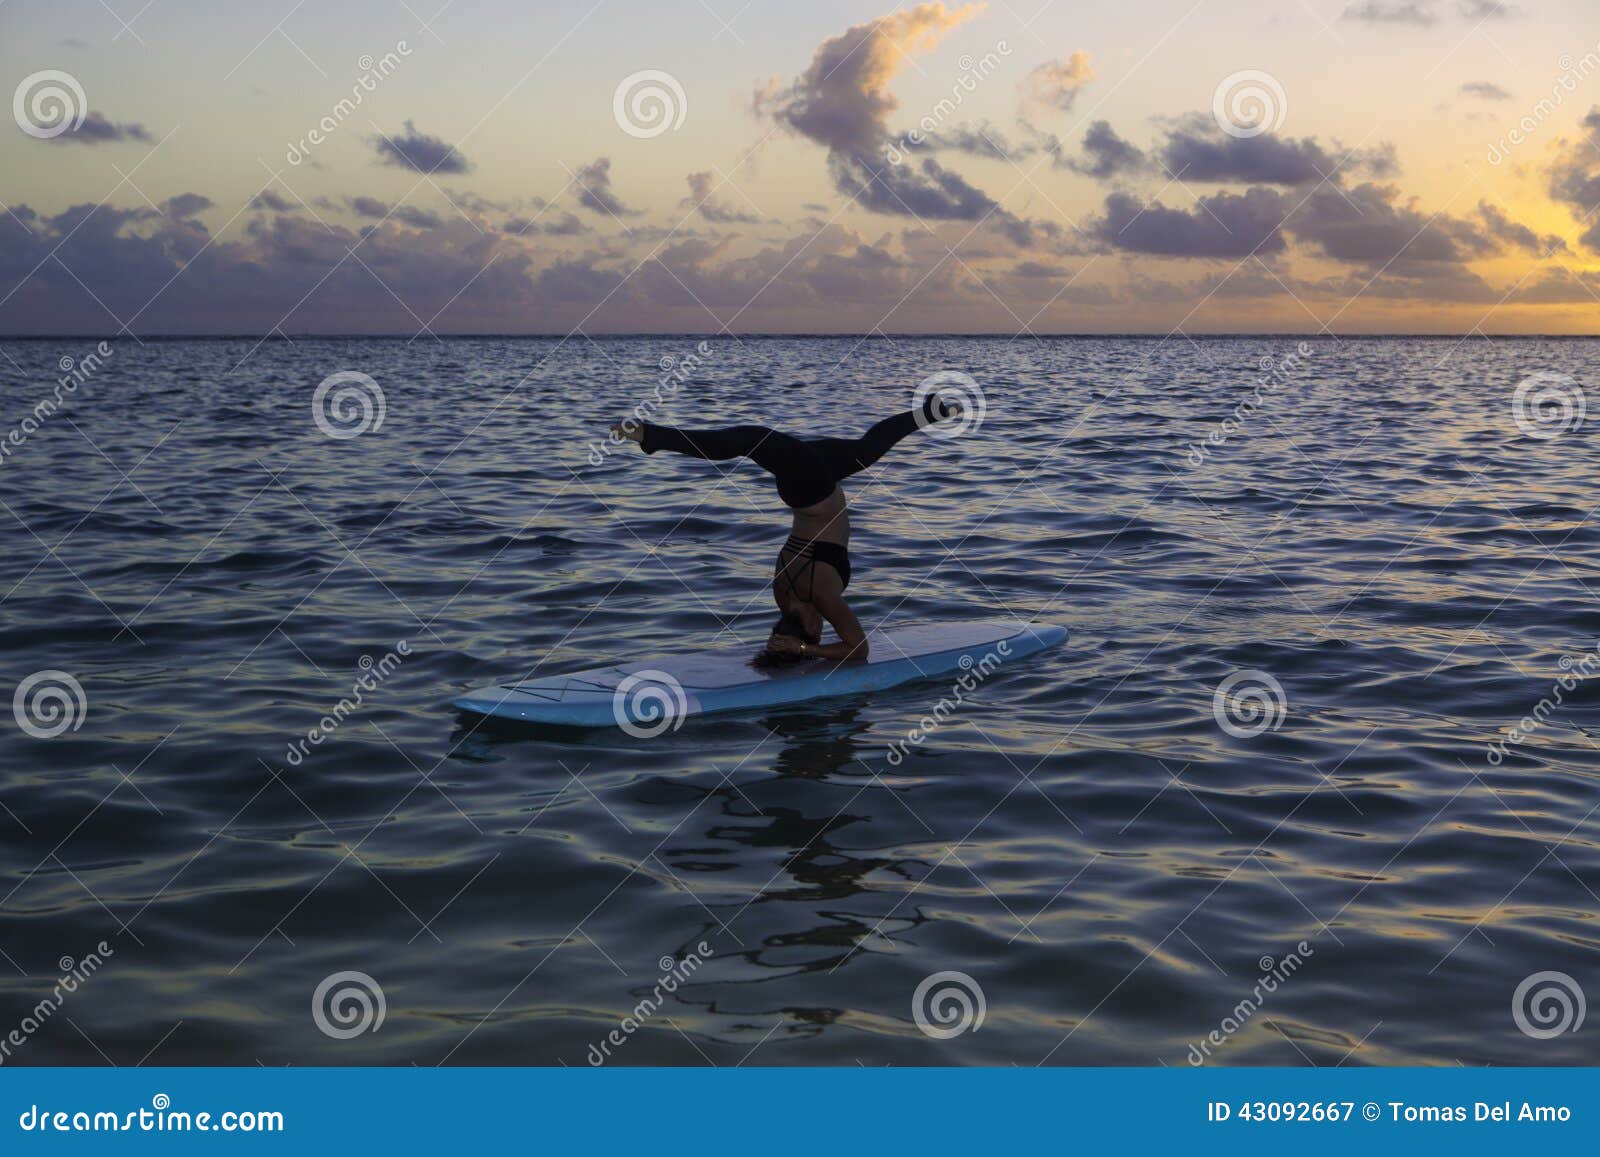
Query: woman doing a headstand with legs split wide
[{"left": 611, "top": 395, "right": 958, "bottom": 663}]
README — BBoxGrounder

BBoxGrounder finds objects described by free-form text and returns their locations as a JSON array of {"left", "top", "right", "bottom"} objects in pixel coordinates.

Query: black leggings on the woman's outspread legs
[{"left": 640, "top": 410, "right": 918, "bottom": 507}]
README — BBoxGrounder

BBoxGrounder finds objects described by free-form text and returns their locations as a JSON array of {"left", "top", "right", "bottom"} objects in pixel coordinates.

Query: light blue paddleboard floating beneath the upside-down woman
[{"left": 454, "top": 619, "right": 1067, "bottom": 735}]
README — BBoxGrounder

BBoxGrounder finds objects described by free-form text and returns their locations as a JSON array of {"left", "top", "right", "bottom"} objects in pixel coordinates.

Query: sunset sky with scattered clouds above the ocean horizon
[{"left": 0, "top": 0, "right": 1600, "bottom": 338}]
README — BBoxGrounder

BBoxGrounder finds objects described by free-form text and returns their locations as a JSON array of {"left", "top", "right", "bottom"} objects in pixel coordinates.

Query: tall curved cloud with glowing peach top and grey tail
[{"left": 755, "top": 3, "right": 1030, "bottom": 228}]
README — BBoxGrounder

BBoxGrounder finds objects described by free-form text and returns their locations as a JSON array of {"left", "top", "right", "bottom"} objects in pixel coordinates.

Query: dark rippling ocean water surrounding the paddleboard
[{"left": 0, "top": 336, "right": 1600, "bottom": 1066}]
